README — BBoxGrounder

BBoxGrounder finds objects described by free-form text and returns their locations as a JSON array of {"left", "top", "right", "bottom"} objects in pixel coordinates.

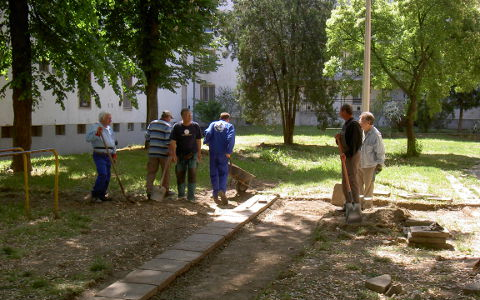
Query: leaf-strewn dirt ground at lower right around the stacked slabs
[{"left": 258, "top": 209, "right": 480, "bottom": 300}]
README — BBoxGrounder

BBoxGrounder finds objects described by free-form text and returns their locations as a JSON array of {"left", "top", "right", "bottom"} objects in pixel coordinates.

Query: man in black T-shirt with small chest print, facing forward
[{"left": 170, "top": 108, "right": 202, "bottom": 201}]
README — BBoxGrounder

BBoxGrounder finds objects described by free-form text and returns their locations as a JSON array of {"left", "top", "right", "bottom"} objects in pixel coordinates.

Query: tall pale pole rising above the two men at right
[{"left": 362, "top": 0, "right": 372, "bottom": 112}]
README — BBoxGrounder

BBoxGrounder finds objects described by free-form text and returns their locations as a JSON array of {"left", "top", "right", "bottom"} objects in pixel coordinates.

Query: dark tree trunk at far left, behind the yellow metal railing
[{"left": 8, "top": 0, "right": 33, "bottom": 172}]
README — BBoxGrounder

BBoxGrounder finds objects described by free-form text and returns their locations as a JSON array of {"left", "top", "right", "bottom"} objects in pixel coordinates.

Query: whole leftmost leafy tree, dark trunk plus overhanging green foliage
[{"left": 0, "top": 0, "right": 128, "bottom": 171}]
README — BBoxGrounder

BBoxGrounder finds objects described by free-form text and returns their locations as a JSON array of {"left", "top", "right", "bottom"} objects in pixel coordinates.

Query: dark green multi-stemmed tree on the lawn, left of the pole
[{"left": 224, "top": 0, "right": 335, "bottom": 144}]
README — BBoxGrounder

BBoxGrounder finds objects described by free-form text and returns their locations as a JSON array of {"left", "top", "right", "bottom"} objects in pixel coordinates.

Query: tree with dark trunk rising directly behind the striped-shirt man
[{"left": 100, "top": 0, "right": 218, "bottom": 123}]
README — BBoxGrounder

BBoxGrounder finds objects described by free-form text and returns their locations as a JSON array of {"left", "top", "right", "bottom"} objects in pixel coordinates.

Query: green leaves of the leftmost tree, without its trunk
[{"left": 0, "top": 0, "right": 136, "bottom": 109}]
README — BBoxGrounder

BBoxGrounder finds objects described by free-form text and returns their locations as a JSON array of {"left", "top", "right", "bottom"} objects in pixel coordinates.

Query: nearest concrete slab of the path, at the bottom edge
[{"left": 95, "top": 281, "right": 158, "bottom": 300}]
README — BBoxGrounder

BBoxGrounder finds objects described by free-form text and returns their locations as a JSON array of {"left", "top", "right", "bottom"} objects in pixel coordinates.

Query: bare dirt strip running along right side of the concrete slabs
[{"left": 153, "top": 200, "right": 334, "bottom": 300}]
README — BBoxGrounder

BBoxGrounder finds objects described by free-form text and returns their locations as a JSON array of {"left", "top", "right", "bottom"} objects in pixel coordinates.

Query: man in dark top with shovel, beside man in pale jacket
[{"left": 336, "top": 104, "right": 363, "bottom": 203}]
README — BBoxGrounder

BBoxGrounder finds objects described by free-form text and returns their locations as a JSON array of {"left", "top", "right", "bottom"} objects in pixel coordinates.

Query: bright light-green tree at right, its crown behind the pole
[{"left": 326, "top": 0, "right": 480, "bottom": 156}]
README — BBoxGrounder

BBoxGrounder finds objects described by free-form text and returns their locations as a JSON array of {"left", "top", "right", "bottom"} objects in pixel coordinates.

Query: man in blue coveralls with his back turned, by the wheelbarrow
[{"left": 203, "top": 112, "right": 235, "bottom": 205}]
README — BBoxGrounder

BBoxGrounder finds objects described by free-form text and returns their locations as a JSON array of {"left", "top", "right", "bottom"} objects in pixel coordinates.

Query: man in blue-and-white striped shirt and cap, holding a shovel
[{"left": 145, "top": 110, "right": 174, "bottom": 200}]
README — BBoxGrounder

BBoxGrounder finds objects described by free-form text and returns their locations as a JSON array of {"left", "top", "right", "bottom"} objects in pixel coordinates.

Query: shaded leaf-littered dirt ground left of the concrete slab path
[{"left": 0, "top": 191, "right": 252, "bottom": 300}]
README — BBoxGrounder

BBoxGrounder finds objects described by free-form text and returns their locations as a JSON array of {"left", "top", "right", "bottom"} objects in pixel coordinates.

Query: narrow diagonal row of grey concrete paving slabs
[{"left": 92, "top": 195, "right": 277, "bottom": 300}]
